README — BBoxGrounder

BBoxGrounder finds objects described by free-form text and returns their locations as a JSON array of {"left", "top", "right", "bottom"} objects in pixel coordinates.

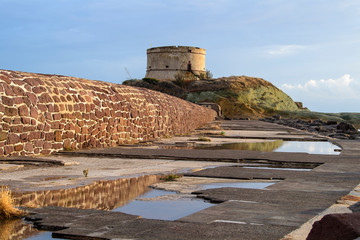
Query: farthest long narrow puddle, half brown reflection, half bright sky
[{"left": 194, "top": 140, "right": 341, "bottom": 155}]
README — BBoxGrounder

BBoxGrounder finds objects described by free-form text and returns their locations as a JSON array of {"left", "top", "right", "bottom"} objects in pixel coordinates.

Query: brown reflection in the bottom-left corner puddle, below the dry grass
[{"left": 0, "top": 219, "right": 40, "bottom": 240}]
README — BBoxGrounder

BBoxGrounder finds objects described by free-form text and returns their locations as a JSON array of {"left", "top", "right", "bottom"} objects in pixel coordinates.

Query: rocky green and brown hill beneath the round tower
[{"left": 125, "top": 76, "right": 306, "bottom": 118}]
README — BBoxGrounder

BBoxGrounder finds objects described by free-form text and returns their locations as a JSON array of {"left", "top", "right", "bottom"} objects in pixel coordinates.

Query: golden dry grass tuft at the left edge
[{"left": 0, "top": 186, "right": 25, "bottom": 219}]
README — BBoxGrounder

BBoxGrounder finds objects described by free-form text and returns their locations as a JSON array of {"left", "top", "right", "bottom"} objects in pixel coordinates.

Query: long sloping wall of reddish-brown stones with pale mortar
[{"left": 0, "top": 70, "right": 216, "bottom": 156}]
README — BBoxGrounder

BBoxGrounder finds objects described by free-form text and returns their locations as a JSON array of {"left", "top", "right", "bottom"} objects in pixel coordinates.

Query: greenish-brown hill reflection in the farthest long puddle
[{"left": 195, "top": 140, "right": 284, "bottom": 152}]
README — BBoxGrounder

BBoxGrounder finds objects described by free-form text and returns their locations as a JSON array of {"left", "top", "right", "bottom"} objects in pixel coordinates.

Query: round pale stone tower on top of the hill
[{"left": 145, "top": 46, "right": 206, "bottom": 80}]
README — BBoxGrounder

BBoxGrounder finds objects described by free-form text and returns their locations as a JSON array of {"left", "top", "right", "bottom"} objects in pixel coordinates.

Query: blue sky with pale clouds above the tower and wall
[{"left": 0, "top": 0, "right": 360, "bottom": 112}]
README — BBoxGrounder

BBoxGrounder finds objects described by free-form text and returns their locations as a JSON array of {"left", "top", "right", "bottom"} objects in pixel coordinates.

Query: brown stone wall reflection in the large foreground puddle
[{"left": 14, "top": 175, "right": 161, "bottom": 210}]
